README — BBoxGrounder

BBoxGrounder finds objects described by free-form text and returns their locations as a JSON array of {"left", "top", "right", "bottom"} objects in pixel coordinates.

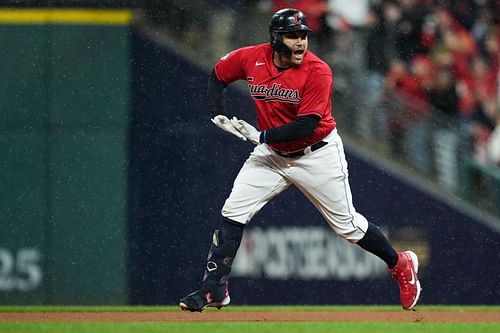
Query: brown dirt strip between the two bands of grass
[{"left": 0, "top": 310, "right": 500, "bottom": 323}]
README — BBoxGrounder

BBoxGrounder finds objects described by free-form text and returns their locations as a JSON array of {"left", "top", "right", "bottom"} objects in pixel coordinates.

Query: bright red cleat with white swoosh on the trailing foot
[{"left": 389, "top": 251, "right": 422, "bottom": 310}]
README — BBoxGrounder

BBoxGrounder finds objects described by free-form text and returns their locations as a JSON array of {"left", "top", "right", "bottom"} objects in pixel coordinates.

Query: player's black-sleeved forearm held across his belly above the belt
[{"left": 260, "top": 115, "right": 320, "bottom": 143}]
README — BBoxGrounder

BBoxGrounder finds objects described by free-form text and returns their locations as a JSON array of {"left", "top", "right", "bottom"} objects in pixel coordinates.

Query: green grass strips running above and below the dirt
[{"left": 0, "top": 306, "right": 500, "bottom": 333}]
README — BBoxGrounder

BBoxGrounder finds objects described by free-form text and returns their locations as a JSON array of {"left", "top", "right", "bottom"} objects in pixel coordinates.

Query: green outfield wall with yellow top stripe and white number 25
[{"left": 0, "top": 9, "right": 131, "bottom": 304}]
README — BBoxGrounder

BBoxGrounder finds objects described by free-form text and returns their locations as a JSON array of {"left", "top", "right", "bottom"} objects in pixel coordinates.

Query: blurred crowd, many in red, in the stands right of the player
[{"left": 322, "top": 0, "right": 500, "bottom": 169}]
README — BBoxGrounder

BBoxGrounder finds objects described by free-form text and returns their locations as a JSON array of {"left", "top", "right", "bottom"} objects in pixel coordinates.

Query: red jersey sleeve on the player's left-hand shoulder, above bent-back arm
[{"left": 214, "top": 48, "right": 247, "bottom": 84}]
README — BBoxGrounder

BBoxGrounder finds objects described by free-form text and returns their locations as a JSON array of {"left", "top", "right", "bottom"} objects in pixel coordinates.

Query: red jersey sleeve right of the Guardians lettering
[{"left": 297, "top": 65, "right": 333, "bottom": 118}]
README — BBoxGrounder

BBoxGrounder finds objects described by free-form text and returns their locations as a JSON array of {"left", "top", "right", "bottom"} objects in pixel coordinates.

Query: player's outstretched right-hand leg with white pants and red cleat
[{"left": 289, "top": 129, "right": 422, "bottom": 310}]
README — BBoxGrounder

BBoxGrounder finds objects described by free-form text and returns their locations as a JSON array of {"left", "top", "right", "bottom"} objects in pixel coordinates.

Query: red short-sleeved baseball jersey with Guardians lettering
[{"left": 214, "top": 43, "right": 336, "bottom": 152}]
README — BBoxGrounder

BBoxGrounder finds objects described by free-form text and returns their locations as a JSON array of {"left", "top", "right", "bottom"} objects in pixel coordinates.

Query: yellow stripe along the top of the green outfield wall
[{"left": 0, "top": 8, "right": 132, "bottom": 25}]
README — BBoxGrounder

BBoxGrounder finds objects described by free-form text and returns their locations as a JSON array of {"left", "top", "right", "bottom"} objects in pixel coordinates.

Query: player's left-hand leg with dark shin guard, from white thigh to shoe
[{"left": 179, "top": 146, "right": 290, "bottom": 312}]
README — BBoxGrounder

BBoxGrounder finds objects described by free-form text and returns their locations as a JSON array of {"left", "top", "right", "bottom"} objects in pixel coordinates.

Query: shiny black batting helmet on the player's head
[{"left": 269, "top": 8, "right": 311, "bottom": 55}]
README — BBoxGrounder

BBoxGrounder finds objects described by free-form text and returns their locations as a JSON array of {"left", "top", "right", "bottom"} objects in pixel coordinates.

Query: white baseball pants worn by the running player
[{"left": 222, "top": 129, "right": 368, "bottom": 243}]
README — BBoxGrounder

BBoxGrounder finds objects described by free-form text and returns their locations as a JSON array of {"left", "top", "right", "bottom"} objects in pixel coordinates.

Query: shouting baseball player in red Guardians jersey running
[{"left": 179, "top": 8, "right": 421, "bottom": 311}]
